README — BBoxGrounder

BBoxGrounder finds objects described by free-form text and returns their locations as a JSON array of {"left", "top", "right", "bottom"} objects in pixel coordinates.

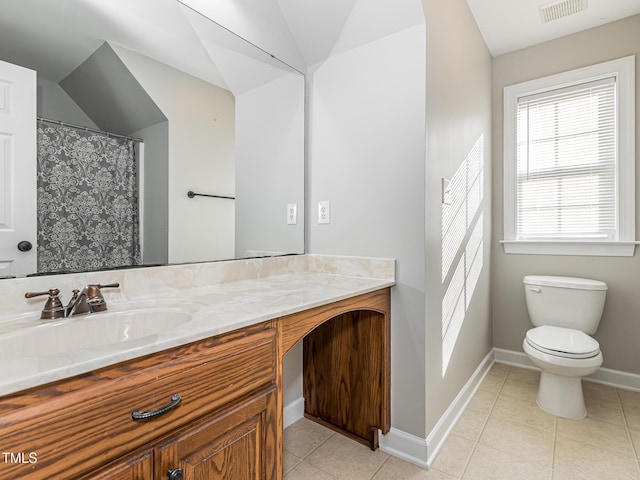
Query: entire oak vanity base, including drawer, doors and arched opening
[{"left": 0, "top": 288, "right": 390, "bottom": 480}]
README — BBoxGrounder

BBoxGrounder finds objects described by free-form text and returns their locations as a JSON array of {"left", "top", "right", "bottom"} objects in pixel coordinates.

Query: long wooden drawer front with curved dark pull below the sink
[{"left": 0, "top": 329, "right": 276, "bottom": 480}]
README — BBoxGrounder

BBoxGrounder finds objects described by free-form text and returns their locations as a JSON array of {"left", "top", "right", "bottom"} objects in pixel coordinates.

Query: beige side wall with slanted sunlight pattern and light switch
[{"left": 423, "top": 0, "right": 492, "bottom": 432}]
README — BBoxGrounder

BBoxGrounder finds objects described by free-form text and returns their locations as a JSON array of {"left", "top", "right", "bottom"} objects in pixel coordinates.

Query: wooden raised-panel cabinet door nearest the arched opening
[{"left": 155, "top": 386, "right": 278, "bottom": 480}]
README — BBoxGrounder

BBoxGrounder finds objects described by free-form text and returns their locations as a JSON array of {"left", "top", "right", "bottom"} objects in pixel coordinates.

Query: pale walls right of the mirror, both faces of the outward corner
[{"left": 308, "top": 0, "right": 492, "bottom": 447}]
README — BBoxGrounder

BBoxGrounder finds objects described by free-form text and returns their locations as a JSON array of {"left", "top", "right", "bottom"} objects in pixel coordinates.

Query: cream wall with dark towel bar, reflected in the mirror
[{"left": 114, "top": 47, "right": 235, "bottom": 263}]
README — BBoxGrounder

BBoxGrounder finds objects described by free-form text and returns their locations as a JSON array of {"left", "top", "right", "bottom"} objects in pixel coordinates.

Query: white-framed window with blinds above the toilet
[{"left": 503, "top": 57, "right": 635, "bottom": 255}]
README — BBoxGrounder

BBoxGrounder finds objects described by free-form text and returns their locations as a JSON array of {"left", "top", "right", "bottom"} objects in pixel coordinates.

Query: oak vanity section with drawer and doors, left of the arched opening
[{"left": 0, "top": 322, "right": 280, "bottom": 480}]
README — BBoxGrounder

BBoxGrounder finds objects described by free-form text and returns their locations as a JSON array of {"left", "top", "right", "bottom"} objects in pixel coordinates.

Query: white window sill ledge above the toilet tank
[{"left": 500, "top": 240, "right": 639, "bottom": 257}]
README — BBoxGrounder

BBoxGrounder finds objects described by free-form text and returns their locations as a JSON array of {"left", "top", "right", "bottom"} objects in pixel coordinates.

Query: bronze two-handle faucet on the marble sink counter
[{"left": 24, "top": 283, "right": 120, "bottom": 320}]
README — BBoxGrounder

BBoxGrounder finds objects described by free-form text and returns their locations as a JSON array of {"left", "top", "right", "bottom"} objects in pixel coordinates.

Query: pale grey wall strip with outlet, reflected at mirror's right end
[{"left": 235, "top": 73, "right": 305, "bottom": 257}]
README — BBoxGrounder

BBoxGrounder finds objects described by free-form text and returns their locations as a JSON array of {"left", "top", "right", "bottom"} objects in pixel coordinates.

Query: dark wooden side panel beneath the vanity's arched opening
[{"left": 303, "top": 310, "right": 391, "bottom": 450}]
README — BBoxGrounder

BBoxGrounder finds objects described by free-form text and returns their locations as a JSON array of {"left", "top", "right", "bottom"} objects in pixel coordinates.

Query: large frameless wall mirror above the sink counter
[{"left": 0, "top": 0, "right": 304, "bottom": 277}]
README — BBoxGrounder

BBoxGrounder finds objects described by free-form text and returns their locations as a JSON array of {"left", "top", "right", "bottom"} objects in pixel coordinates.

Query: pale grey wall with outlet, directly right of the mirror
[{"left": 308, "top": 26, "right": 426, "bottom": 438}]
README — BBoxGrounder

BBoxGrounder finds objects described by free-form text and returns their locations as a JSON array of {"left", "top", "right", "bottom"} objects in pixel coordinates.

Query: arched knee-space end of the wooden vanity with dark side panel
[{"left": 278, "top": 288, "right": 391, "bottom": 450}]
